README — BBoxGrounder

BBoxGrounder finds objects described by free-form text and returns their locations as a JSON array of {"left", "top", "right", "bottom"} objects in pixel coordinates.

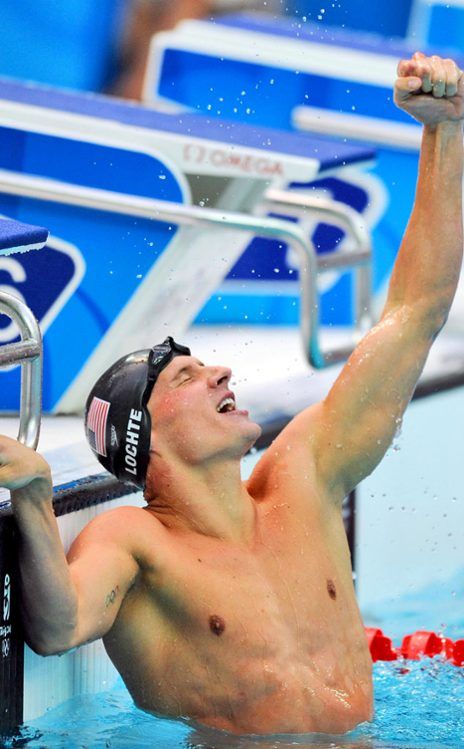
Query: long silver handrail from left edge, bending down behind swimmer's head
[{"left": 0, "top": 170, "right": 374, "bottom": 369}]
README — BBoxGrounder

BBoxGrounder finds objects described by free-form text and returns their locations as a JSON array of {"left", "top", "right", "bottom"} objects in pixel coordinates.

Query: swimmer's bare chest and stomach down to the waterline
[{"left": 103, "top": 506, "right": 369, "bottom": 730}]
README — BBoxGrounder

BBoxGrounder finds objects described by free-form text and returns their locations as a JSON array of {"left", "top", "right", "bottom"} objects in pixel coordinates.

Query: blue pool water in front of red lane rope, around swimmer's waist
[{"left": 10, "top": 659, "right": 464, "bottom": 749}]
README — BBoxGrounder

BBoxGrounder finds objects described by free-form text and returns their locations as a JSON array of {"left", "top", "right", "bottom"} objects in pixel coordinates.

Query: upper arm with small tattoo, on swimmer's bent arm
[{"left": 68, "top": 522, "right": 138, "bottom": 647}]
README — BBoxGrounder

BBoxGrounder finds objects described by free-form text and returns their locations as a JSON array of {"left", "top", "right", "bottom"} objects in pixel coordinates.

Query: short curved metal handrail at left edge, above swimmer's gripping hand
[{"left": 0, "top": 291, "right": 42, "bottom": 450}]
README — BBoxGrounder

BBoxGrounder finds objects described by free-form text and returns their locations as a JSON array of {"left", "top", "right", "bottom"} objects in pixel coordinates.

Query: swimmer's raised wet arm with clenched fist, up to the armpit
[{"left": 280, "top": 53, "right": 464, "bottom": 500}]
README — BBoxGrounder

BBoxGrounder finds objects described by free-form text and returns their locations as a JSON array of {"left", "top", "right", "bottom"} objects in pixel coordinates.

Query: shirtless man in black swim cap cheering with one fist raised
[{"left": 0, "top": 54, "right": 464, "bottom": 734}]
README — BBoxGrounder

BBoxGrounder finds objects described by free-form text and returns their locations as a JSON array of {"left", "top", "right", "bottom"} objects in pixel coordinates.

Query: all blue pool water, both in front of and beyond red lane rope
[{"left": 13, "top": 570, "right": 464, "bottom": 749}]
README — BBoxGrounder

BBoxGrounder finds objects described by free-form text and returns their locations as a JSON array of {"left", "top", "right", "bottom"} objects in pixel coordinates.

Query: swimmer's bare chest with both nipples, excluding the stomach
[{"left": 127, "top": 501, "right": 359, "bottom": 650}]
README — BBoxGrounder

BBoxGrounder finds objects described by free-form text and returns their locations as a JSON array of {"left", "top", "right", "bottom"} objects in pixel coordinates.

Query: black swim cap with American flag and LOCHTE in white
[{"left": 84, "top": 337, "right": 190, "bottom": 489}]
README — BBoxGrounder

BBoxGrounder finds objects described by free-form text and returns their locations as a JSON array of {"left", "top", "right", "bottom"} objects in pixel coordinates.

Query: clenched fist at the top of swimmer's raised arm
[{"left": 395, "top": 52, "right": 464, "bottom": 125}]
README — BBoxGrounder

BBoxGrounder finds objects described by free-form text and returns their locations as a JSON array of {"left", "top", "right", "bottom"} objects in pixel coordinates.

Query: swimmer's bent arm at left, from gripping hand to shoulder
[{"left": 0, "top": 437, "right": 138, "bottom": 655}]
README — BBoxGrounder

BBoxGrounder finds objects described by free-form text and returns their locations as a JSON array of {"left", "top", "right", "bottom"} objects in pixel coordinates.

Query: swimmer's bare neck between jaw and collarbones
[{"left": 145, "top": 460, "right": 255, "bottom": 543}]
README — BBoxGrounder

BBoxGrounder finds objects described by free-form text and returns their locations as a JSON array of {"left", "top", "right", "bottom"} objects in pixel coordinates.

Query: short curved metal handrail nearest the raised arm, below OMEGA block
[{"left": 266, "top": 189, "right": 374, "bottom": 337}]
